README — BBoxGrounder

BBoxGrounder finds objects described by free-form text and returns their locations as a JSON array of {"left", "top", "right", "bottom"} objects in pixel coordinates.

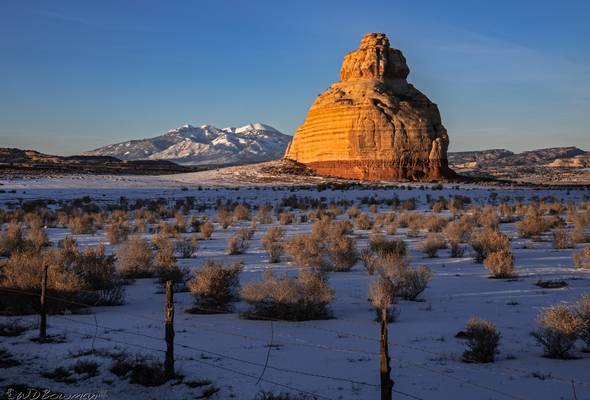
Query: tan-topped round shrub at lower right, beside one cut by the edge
[{"left": 532, "top": 304, "right": 582, "bottom": 358}]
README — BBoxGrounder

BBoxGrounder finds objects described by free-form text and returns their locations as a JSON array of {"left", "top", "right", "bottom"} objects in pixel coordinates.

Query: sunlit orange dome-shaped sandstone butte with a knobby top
[{"left": 285, "top": 33, "right": 453, "bottom": 180}]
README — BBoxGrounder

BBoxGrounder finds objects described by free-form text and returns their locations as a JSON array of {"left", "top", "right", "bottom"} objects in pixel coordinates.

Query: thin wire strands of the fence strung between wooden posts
[{"left": 0, "top": 288, "right": 590, "bottom": 400}]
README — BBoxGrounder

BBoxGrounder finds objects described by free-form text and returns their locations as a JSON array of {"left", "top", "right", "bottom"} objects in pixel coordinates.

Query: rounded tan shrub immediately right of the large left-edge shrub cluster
[{"left": 116, "top": 237, "right": 154, "bottom": 279}]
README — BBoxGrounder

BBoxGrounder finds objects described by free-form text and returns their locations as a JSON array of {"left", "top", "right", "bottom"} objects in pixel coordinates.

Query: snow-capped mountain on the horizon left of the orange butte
[{"left": 84, "top": 122, "right": 291, "bottom": 165}]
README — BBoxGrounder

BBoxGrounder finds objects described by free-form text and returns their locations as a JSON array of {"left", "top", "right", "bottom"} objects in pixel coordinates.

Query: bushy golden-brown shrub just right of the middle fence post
[{"left": 188, "top": 260, "right": 242, "bottom": 313}]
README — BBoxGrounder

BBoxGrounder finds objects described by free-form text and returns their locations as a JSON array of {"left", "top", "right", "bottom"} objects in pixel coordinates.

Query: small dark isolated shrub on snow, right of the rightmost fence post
[{"left": 463, "top": 317, "right": 500, "bottom": 363}]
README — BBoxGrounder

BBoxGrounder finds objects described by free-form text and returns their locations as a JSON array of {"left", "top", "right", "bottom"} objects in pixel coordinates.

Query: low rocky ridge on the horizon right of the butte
[{"left": 448, "top": 147, "right": 590, "bottom": 170}]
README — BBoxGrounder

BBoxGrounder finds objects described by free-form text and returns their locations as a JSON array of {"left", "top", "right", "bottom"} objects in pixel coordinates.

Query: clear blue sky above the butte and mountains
[{"left": 0, "top": 0, "right": 590, "bottom": 154}]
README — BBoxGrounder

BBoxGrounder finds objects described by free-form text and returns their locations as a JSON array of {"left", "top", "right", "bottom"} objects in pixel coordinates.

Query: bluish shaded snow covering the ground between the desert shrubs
[{"left": 0, "top": 179, "right": 590, "bottom": 400}]
